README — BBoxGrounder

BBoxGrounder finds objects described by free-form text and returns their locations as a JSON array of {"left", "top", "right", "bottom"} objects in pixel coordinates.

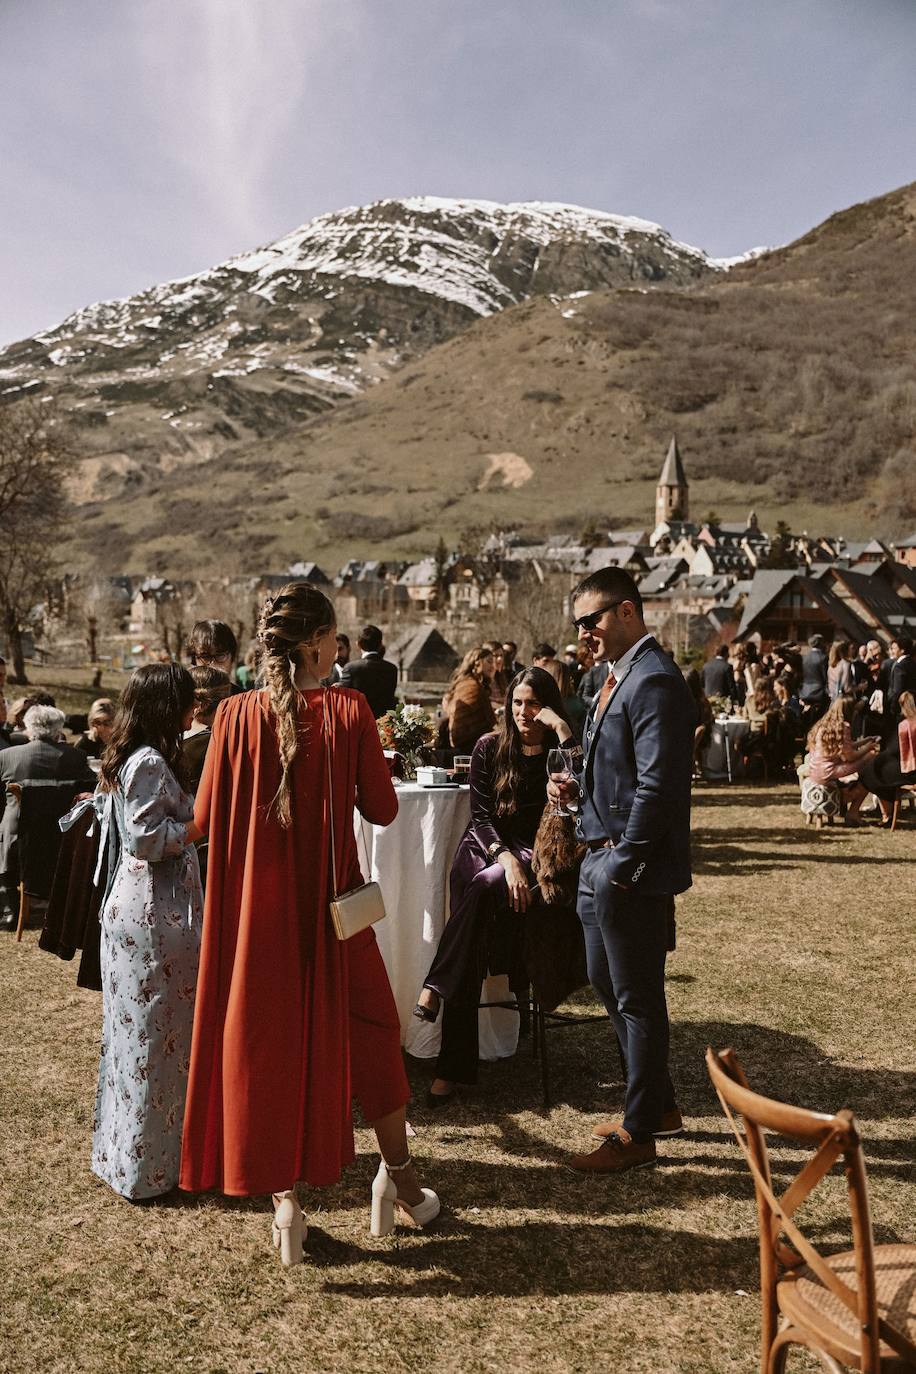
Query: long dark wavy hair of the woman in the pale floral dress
[{"left": 99, "top": 664, "right": 194, "bottom": 791}]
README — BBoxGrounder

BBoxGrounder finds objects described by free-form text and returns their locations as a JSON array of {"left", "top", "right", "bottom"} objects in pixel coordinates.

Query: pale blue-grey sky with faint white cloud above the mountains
[{"left": 0, "top": 0, "right": 916, "bottom": 345}]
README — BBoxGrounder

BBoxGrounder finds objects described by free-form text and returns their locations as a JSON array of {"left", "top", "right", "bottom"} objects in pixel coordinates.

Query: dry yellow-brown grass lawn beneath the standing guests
[{"left": 0, "top": 787, "right": 916, "bottom": 1374}]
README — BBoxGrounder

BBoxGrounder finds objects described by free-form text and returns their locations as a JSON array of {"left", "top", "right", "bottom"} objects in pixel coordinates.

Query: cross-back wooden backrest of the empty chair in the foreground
[{"left": 706, "top": 1048, "right": 916, "bottom": 1371}]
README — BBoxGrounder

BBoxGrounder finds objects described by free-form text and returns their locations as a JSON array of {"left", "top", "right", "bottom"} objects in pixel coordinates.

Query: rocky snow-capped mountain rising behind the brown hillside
[{"left": 0, "top": 196, "right": 717, "bottom": 483}]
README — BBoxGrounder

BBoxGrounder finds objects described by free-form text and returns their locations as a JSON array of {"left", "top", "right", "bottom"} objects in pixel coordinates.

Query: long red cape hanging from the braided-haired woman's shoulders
[{"left": 180, "top": 688, "right": 397, "bottom": 1195}]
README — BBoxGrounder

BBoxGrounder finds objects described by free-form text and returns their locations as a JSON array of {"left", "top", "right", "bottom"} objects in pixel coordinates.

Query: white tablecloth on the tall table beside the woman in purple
[{"left": 356, "top": 783, "right": 519, "bottom": 1059}]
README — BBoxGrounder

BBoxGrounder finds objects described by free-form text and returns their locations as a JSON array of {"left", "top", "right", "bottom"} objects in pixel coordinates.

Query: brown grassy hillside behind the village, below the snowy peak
[{"left": 62, "top": 187, "right": 916, "bottom": 576}]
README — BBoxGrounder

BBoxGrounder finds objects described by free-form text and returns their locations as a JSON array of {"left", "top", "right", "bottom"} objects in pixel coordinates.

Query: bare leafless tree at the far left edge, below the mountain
[{"left": 0, "top": 400, "right": 74, "bottom": 683}]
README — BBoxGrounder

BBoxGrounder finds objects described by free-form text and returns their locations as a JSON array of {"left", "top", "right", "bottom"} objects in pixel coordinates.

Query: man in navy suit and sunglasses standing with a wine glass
[{"left": 548, "top": 567, "right": 696, "bottom": 1173}]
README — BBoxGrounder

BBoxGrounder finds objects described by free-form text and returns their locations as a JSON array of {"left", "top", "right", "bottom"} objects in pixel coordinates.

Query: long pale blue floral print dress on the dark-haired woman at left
[{"left": 92, "top": 747, "right": 202, "bottom": 1200}]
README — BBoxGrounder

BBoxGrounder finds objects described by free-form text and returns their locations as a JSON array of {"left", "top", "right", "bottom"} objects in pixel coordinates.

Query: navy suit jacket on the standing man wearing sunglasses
[{"left": 577, "top": 639, "right": 698, "bottom": 896}]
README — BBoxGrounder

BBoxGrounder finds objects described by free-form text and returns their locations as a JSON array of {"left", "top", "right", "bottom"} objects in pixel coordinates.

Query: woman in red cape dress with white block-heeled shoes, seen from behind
[{"left": 180, "top": 583, "right": 438, "bottom": 1264}]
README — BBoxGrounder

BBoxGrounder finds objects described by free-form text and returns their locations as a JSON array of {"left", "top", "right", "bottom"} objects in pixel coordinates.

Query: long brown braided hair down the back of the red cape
[{"left": 257, "top": 583, "right": 336, "bottom": 830}]
